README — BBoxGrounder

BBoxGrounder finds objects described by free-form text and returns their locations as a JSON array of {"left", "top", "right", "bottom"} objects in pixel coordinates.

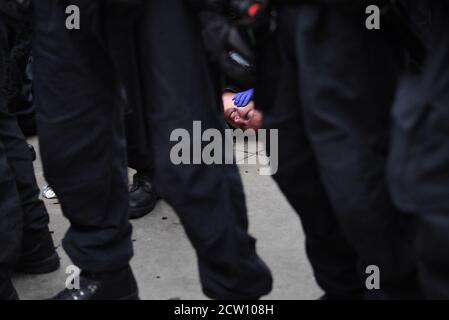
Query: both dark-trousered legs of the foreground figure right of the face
[{"left": 255, "top": 1, "right": 420, "bottom": 299}]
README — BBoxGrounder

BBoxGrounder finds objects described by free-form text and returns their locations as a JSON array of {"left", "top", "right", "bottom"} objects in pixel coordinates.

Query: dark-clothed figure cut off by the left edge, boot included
[{"left": 0, "top": 0, "right": 59, "bottom": 300}]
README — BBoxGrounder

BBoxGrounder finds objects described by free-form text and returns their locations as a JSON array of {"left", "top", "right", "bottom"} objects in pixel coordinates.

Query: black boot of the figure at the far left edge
[{"left": 15, "top": 230, "right": 61, "bottom": 274}]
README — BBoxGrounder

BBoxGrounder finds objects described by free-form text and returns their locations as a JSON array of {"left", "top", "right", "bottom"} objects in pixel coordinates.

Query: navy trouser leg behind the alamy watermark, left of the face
[{"left": 140, "top": 0, "right": 272, "bottom": 299}]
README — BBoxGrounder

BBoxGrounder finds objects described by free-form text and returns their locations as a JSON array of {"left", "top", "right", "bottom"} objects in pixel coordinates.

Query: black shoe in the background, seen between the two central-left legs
[{"left": 129, "top": 173, "right": 159, "bottom": 219}]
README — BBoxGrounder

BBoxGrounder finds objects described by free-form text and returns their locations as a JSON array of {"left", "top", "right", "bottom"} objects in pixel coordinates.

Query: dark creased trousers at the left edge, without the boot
[{"left": 0, "top": 16, "right": 49, "bottom": 282}]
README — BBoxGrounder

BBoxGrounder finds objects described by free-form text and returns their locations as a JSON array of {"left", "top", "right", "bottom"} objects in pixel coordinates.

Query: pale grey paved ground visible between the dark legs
[{"left": 14, "top": 139, "right": 321, "bottom": 300}]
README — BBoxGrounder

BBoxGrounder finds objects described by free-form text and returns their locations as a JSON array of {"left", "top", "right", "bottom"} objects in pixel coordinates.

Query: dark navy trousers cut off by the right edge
[{"left": 389, "top": 1, "right": 449, "bottom": 299}]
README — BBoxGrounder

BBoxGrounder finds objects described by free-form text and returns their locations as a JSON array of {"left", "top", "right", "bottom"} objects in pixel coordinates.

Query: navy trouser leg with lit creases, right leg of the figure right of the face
[{"left": 260, "top": 5, "right": 417, "bottom": 299}]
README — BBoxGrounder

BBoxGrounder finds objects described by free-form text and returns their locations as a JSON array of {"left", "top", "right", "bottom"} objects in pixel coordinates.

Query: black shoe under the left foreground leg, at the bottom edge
[{"left": 52, "top": 267, "right": 139, "bottom": 300}]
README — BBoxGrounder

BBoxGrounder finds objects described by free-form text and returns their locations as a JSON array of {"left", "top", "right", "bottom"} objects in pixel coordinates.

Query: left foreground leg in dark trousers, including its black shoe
[{"left": 34, "top": 0, "right": 137, "bottom": 299}]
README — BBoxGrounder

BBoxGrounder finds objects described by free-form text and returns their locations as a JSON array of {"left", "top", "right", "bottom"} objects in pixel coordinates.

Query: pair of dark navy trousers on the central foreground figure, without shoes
[{"left": 35, "top": 0, "right": 272, "bottom": 299}]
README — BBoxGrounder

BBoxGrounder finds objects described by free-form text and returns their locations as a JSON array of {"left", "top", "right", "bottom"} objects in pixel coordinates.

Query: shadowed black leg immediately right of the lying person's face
[{"left": 256, "top": 6, "right": 364, "bottom": 299}]
